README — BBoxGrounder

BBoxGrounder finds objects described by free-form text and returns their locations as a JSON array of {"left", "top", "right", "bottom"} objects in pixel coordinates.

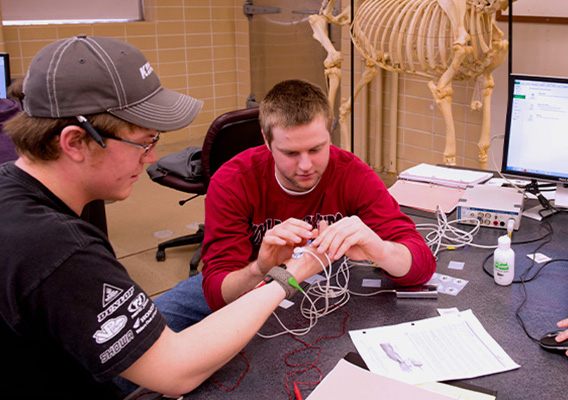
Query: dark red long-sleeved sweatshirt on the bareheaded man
[{"left": 202, "top": 145, "right": 436, "bottom": 311}]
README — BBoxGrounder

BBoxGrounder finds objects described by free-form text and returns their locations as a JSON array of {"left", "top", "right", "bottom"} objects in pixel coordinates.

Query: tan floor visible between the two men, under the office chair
[{"left": 106, "top": 142, "right": 395, "bottom": 297}]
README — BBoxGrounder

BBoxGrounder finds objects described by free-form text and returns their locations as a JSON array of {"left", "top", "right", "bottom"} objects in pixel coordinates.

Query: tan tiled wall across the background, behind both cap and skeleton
[{"left": 0, "top": 0, "right": 568, "bottom": 171}]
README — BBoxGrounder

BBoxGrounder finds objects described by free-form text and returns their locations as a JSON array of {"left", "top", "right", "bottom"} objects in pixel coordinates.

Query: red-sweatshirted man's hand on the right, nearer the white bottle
[{"left": 312, "top": 216, "right": 383, "bottom": 261}]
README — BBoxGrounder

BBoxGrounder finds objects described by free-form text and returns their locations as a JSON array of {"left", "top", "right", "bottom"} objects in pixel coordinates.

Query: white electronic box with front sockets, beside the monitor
[{"left": 457, "top": 185, "right": 524, "bottom": 230}]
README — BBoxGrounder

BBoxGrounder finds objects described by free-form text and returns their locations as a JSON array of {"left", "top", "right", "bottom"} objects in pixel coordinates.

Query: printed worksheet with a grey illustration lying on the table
[{"left": 349, "top": 310, "right": 520, "bottom": 384}]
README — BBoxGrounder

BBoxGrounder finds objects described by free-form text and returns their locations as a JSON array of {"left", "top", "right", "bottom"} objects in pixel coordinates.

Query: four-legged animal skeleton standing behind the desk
[{"left": 310, "top": 0, "right": 508, "bottom": 169}]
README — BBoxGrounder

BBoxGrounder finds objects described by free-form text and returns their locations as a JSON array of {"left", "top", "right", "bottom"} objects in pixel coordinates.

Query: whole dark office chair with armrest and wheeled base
[{"left": 145, "top": 107, "right": 264, "bottom": 276}]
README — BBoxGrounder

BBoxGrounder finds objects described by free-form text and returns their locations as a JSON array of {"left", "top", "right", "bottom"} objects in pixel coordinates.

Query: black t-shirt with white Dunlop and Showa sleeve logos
[{"left": 0, "top": 163, "right": 165, "bottom": 399}]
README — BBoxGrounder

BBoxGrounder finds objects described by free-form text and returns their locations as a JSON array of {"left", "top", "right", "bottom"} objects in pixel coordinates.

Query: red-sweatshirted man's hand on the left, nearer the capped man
[{"left": 256, "top": 218, "right": 313, "bottom": 275}]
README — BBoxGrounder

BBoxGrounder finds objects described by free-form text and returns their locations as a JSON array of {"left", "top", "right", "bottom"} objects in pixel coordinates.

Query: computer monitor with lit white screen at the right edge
[{"left": 501, "top": 74, "right": 568, "bottom": 208}]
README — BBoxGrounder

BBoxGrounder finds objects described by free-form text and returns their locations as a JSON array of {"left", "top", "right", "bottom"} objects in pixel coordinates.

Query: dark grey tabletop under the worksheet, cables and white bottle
[{"left": 173, "top": 205, "right": 568, "bottom": 400}]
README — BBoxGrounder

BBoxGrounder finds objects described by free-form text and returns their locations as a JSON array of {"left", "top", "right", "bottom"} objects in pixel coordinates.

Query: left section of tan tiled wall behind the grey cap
[{"left": 0, "top": 0, "right": 250, "bottom": 143}]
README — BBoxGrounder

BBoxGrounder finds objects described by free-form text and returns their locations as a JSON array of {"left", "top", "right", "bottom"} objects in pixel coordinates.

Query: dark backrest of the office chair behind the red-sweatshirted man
[{"left": 201, "top": 107, "right": 264, "bottom": 186}]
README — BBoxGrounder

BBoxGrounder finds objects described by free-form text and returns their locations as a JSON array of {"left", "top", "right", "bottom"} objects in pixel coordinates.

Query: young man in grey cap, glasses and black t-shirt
[{"left": 0, "top": 36, "right": 321, "bottom": 399}]
